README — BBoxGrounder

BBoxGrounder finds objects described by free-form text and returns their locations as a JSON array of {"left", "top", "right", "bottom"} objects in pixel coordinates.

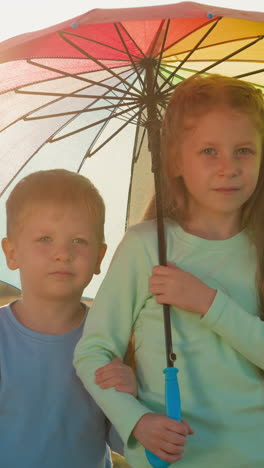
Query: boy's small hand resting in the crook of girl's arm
[{"left": 95, "top": 358, "right": 137, "bottom": 397}]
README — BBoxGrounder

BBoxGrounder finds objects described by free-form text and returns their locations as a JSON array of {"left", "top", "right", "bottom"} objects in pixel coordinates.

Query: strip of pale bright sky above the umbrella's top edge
[{"left": 0, "top": 0, "right": 264, "bottom": 41}]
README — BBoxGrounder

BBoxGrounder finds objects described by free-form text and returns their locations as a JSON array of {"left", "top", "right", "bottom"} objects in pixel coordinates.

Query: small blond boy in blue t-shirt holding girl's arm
[{"left": 0, "top": 169, "right": 133, "bottom": 468}]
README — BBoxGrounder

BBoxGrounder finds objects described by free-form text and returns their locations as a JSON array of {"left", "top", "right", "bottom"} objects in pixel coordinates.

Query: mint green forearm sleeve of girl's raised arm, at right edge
[{"left": 201, "top": 290, "right": 264, "bottom": 369}]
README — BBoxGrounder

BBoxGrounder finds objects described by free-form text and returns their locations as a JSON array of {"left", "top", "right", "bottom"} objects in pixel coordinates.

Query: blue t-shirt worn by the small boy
[{"left": 0, "top": 306, "right": 121, "bottom": 468}]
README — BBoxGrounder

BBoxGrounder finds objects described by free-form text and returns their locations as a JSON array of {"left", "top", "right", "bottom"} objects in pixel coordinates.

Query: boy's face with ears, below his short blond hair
[{"left": 2, "top": 202, "right": 106, "bottom": 300}]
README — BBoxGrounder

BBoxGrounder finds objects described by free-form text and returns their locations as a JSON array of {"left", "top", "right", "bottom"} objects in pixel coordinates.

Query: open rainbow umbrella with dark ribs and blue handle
[{"left": 0, "top": 2, "right": 264, "bottom": 467}]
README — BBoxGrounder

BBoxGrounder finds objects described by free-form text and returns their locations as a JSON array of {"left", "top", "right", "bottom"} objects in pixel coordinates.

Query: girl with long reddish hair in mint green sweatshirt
[{"left": 75, "top": 75, "right": 264, "bottom": 468}]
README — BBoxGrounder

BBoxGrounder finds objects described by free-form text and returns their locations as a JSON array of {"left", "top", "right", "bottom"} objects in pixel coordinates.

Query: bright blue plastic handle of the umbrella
[{"left": 146, "top": 367, "right": 181, "bottom": 468}]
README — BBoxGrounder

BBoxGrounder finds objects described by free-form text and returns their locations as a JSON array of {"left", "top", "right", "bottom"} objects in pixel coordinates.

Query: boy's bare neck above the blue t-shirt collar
[{"left": 12, "top": 297, "right": 85, "bottom": 335}]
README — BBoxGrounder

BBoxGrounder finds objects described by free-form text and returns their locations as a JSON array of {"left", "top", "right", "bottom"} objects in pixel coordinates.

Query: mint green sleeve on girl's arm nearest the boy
[{"left": 74, "top": 230, "right": 154, "bottom": 442}]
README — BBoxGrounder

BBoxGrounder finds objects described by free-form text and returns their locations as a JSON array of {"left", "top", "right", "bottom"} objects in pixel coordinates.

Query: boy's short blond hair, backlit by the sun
[{"left": 6, "top": 169, "right": 105, "bottom": 243}]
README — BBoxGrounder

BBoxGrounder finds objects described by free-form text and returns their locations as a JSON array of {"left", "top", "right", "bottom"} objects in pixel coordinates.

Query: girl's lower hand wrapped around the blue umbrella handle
[{"left": 133, "top": 413, "right": 194, "bottom": 463}]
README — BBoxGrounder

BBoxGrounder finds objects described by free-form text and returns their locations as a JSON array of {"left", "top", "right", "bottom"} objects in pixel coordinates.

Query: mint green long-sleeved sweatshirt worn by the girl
[{"left": 74, "top": 221, "right": 264, "bottom": 468}]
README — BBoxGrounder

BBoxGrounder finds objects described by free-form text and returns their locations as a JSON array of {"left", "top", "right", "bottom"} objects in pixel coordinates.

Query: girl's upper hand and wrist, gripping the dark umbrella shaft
[{"left": 149, "top": 262, "right": 216, "bottom": 315}]
